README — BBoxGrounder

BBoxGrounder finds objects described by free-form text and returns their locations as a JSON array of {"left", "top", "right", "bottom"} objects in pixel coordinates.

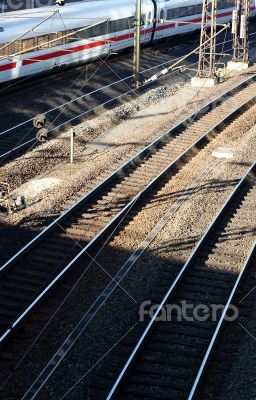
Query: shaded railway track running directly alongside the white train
[{"left": 0, "top": 38, "right": 197, "bottom": 162}]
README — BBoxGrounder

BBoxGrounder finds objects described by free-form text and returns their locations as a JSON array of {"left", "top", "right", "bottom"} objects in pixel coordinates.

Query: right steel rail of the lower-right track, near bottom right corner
[{"left": 188, "top": 241, "right": 256, "bottom": 400}]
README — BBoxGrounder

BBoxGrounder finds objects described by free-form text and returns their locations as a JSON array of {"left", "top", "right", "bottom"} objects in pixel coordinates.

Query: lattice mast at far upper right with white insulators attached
[{"left": 232, "top": 0, "right": 250, "bottom": 63}]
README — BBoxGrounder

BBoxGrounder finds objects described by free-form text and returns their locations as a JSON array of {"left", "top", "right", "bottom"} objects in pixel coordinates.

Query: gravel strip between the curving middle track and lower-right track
[{"left": 1, "top": 104, "right": 255, "bottom": 400}]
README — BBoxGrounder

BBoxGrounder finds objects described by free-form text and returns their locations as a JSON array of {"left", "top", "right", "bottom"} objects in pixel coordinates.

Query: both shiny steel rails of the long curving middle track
[{"left": 0, "top": 78, "right": 256, "bottom": 343}]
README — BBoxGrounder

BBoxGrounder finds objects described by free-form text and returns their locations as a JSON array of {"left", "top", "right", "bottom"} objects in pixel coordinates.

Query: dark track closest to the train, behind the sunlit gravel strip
[{"left": 0, "top": 33, "right": 255, "bottom": 163}]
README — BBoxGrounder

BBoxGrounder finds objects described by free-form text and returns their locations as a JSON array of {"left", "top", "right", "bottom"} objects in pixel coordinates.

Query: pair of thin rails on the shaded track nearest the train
[{"left": 0, "top": 32, "right": 256, "bottom": 161}]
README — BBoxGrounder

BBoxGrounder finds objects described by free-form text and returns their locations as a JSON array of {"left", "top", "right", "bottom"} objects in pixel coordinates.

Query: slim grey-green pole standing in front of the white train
[{"left": 133, "top": 0, "right": 141, "bottom": 89}]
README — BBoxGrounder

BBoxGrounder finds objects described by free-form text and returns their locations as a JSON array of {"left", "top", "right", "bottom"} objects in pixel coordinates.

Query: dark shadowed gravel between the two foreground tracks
[{"left": 0, "top": 216, "right": 254, "bottom": 400}]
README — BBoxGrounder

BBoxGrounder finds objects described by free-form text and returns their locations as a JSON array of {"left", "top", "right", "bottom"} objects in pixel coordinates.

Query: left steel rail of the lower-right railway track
[{"left": 106, "top": 162, "right": 256, "bottom": 400}]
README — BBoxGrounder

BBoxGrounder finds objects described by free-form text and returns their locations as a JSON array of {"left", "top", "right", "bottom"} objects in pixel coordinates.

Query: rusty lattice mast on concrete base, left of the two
[{"left": 197, "top": 0, "right": 217, "bottom": 78}]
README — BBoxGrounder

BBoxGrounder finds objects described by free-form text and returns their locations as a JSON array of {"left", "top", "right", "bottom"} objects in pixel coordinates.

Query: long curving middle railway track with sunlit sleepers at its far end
[{"left": 0, "top": 76, "right": 256, "bottom": 348}]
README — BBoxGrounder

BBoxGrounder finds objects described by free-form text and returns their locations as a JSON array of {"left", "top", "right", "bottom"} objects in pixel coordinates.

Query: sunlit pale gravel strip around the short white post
[{"left": 0, "top": 67, "right": 254, "bottom": 233}]
